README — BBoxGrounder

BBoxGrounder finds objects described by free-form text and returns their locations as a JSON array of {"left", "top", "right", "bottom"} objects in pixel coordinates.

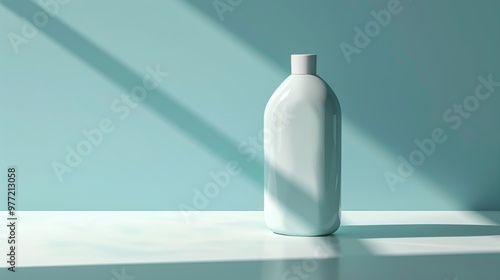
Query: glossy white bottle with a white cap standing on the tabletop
[{"left": 264, "top": 54, "right": 341, "bottom": 236}]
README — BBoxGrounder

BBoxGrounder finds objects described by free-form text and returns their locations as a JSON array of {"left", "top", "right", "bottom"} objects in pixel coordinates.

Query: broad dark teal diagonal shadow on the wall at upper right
[{"left": 187, "top": 0, "right": 500, "bottom": 210}]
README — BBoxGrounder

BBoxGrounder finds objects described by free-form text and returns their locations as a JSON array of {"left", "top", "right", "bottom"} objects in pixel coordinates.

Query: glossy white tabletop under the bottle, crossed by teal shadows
[{"left": 0, "top": 211, "right": 500, "bottom": 280}]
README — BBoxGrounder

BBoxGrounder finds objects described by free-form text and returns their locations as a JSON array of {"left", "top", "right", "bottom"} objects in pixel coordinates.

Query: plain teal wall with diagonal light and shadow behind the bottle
[{"left": 0, "top": 0, "right": 500, "bottom": 210}]
